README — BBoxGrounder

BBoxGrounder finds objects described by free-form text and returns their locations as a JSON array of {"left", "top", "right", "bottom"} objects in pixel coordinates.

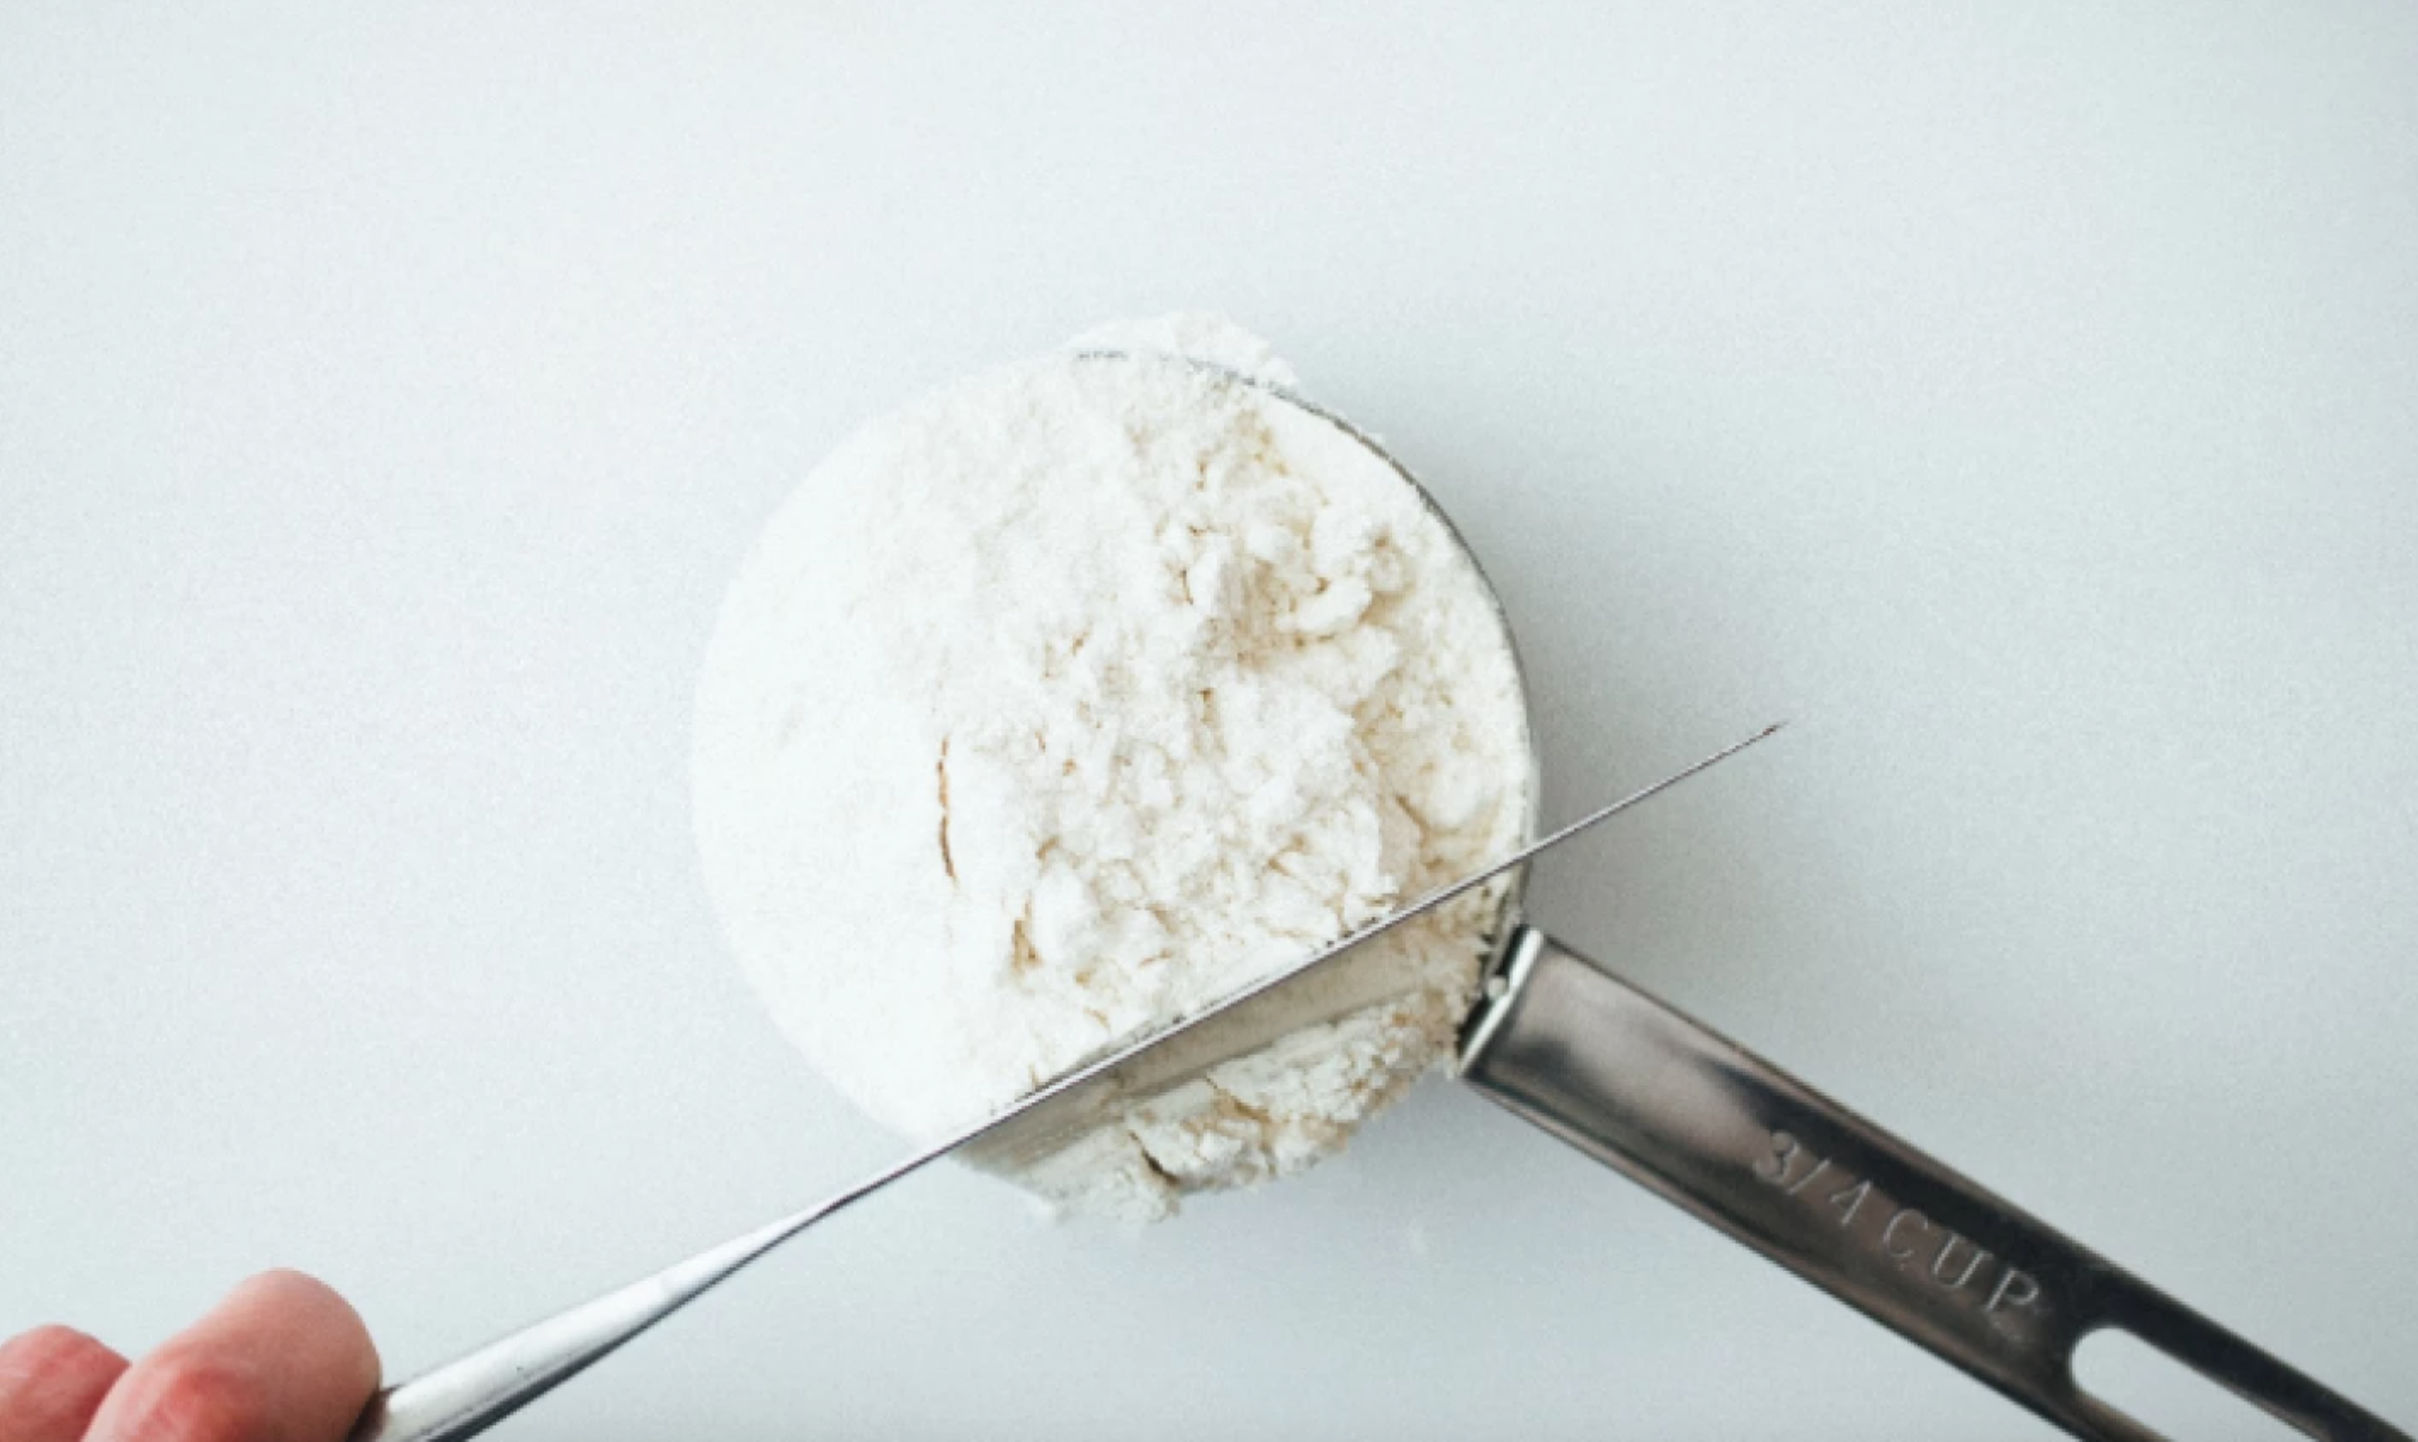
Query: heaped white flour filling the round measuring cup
[{"left": 696, "top": 317, "right": 1531, "bottom": 1217}]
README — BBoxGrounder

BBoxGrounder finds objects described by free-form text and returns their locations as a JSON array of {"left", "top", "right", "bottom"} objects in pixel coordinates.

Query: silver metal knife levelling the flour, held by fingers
[{"left": 353, "top": 726, "right": 1780, "bottom": 1442}]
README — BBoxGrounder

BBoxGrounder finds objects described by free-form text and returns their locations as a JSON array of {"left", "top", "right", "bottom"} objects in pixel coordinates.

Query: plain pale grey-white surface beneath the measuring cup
[{"left": 0, "top": 2, "right": 2418, "bottom": 1440}]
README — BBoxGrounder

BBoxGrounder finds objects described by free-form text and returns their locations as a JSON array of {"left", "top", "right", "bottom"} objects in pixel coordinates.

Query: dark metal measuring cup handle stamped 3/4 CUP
[{"left": 1460, "top": 927, "right": 2408, "bottom": 1442}]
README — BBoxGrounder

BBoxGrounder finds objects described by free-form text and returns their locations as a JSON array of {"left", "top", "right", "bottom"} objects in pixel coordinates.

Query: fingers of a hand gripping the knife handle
[{"left": 0, "top": 1273, "right": 377, "bottom": 1442}]
